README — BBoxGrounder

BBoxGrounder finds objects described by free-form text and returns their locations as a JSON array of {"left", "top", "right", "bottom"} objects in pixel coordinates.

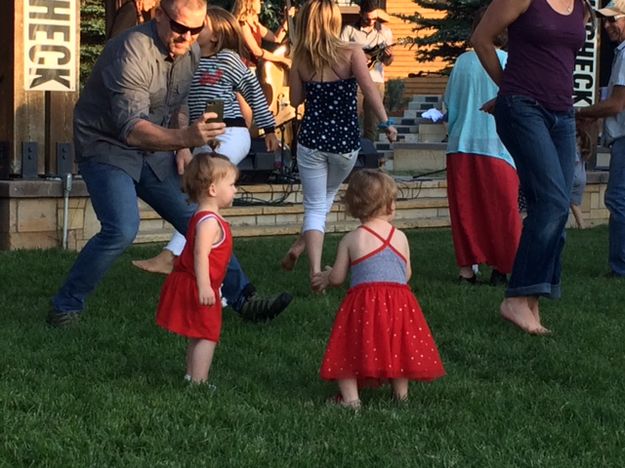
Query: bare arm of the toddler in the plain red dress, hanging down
[{"left": 193, "top": 218, "right": 221, "bottom": 305}]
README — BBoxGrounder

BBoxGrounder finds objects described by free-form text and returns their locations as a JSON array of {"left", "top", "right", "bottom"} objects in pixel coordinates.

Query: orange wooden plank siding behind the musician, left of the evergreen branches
[{"left": 384, "top": 0, "right": 447, "bottom": 80}]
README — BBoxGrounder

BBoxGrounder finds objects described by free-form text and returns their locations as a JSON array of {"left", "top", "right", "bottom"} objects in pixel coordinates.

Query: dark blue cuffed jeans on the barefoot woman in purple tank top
[{"left": 495, "top": 96, "right": 575, "bottom": 298}]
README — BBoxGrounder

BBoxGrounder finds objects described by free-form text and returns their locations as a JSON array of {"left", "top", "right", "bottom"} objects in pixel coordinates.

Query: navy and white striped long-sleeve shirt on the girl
[{"left": 187, "top": 49, "right": 275, "bottom": 133}]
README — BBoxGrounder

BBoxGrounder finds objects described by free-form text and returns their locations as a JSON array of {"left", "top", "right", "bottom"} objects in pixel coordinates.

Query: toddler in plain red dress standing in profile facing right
[{"left": 156, "top": 153, "right": 238, "bottom": 383}]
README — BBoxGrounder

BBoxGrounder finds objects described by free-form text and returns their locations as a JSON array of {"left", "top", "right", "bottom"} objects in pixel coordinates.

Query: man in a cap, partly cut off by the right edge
[{"left": 576, "top": 2, "right": 625, "bottom": 278}]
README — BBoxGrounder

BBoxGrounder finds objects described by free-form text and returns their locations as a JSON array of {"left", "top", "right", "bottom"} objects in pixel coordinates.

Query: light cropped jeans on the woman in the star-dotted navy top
[{"left": 297, "top": 144, "right": 359, "bottom": 232}]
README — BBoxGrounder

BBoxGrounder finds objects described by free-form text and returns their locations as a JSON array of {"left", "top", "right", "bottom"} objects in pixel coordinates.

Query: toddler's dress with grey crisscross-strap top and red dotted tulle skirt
[{"left": 320, "top": 226, "right": 445, "bottom": 384}]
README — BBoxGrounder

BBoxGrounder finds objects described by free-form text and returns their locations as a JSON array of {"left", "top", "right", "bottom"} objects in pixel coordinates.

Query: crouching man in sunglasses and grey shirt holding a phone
[{"left": 47, "top": 0, "right": 291, "bottom": 327}]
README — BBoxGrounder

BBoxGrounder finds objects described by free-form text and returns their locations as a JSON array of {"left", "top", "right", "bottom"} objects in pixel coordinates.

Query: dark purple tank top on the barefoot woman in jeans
[{"left": 499, "top": 0, "right": 586, "bottom": 112}]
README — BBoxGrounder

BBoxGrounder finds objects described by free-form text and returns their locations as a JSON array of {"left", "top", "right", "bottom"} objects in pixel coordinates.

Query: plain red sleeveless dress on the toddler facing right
[{"left": 156, "top": 211, "right": 232, "bottom": 342}]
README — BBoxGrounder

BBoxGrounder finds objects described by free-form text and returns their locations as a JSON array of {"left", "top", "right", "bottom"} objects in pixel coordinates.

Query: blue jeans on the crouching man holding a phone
[{"left": 52, "top": 158, "right": 249, "bottom": 312}]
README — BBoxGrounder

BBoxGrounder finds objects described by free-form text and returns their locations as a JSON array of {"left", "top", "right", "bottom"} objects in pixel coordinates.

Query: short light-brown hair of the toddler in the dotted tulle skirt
[{"left": 343, "top": 169, "right": 397, "bottom": 220}]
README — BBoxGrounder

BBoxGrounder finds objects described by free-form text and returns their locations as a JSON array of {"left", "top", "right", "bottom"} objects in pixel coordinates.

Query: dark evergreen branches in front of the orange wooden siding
[{"left": 398, "top": 0, "right": 490, "bottom": 71}]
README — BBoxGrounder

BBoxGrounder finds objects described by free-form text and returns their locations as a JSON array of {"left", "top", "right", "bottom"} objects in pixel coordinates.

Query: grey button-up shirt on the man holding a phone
[{"left": 74, "top": 21, "right": 199, "bottom": 181}]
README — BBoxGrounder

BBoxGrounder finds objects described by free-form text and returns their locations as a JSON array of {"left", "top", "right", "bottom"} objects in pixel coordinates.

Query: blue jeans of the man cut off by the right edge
[{"left": 605, "top": 137, "right": 625, "bottom": 276}]
